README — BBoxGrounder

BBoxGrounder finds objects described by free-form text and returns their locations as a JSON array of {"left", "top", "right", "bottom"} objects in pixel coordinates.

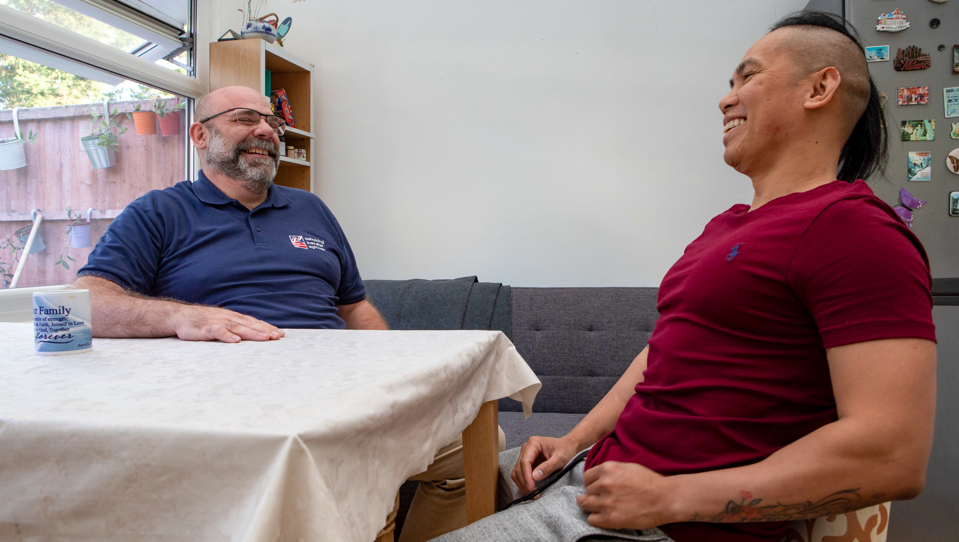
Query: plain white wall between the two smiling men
[{"left": 211, "top": 0, "right": 806, "bottom": 286}]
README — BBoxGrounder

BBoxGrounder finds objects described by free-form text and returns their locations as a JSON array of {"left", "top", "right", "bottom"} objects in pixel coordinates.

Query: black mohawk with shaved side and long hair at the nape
[{"left": 770, "top": 11, "right": 888, "bottom": 183}]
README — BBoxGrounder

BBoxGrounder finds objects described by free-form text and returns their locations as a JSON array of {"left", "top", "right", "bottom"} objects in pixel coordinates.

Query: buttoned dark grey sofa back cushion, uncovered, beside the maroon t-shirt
[{"left": 510, "top": 287, "right": 659, "bottom": 414}]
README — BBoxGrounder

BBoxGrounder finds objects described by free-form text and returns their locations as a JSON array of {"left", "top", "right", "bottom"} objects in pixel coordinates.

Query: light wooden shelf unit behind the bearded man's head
[{"left": 210, "top": 39, "right": 315, "bottom": 192}]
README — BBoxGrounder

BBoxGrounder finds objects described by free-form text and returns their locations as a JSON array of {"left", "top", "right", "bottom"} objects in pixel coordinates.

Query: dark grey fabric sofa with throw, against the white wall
[{"left": 366, "top": 277, "right": 659, "bottom": 532}]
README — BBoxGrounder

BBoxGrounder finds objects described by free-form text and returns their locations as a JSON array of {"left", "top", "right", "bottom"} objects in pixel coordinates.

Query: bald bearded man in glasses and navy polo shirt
[{"left": 74, "top": 87, "right": 387, "bottom": 342}]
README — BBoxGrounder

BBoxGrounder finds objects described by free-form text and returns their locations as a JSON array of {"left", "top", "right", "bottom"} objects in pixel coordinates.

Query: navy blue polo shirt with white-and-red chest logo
[{"left": 77, "top": 171, "right": 366, "bottom": 329}]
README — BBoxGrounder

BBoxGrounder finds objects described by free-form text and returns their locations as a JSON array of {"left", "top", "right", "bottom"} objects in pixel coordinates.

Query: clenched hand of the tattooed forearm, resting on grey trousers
[{"left": 576, "top": 461, "right": 677, "bottom": 530}]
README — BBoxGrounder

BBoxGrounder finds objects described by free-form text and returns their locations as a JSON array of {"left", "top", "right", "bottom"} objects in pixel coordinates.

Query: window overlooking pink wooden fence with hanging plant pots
[{"left": 0, "top": 0, "right": 201, "bottom": 288}]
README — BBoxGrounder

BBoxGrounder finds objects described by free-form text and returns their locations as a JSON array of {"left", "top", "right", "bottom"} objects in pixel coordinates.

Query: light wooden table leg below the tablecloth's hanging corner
[{"left": 463, "top": 401, "right": 499, "bottom": 523}]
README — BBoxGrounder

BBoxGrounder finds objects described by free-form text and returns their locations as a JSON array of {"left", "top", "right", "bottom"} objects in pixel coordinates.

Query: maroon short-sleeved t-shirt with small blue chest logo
[{"left": 586, "top": 181, "right": 935, "bottom": 542}]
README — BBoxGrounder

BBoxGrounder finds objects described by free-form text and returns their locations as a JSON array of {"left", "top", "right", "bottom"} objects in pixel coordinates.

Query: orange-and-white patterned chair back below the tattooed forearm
[{"left": 779, "top": 502, "right": 892, "bottom": 542}]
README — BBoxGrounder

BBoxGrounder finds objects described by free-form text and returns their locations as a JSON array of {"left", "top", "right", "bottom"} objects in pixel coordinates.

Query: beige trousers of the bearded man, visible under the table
[{"left": 376, "top": 427, "right": 506, "bottom": 542}]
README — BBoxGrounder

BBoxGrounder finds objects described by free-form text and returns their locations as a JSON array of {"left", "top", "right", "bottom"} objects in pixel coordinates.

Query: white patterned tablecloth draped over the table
[{"left": 0, "top": 324, "right": 540, "bottom": 542}]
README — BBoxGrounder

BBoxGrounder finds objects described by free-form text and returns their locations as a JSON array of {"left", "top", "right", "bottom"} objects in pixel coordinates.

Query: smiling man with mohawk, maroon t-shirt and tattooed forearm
[{"left": 434, "top": 13, "right": 936, "bottom": 542}]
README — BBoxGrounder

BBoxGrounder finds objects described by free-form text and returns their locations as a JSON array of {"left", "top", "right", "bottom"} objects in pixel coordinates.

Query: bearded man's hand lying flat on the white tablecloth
[{"left": 172, "top": 305, "right": 285, "bottom": 343}]
